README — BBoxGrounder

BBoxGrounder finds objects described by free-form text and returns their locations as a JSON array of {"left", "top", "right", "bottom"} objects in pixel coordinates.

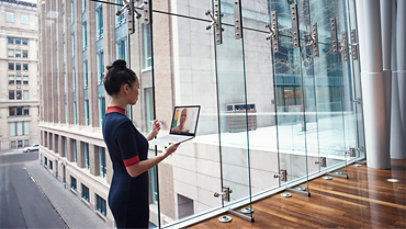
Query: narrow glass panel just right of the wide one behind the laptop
[{"left": 216, "top": 0, "right": 254, "bottom": 211}]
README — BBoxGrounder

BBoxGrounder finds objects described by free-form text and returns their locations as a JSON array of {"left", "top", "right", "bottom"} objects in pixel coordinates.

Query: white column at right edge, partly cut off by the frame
[{"left": 390, "top": 0, "right": 406, "bottom": 159}]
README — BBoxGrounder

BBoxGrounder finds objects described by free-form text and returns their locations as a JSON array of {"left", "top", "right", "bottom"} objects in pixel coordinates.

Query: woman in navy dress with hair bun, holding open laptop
[{"left": 103, "top": 60, "right": 178, "bottom": 228}]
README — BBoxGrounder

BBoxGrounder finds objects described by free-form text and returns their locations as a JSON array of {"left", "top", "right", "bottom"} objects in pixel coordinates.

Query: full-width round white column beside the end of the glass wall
[{"left": 357, "top": 0, "right": 390, "bottom": 169}]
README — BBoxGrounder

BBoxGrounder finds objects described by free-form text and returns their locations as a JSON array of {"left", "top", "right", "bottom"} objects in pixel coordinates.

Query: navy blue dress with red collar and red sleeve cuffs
[{"left": 103, "top": 107, "right": 149, "bottom": 228}]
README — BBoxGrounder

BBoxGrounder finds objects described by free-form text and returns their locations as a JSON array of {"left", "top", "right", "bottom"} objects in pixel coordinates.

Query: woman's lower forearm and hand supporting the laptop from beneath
[{"left": 125, "top": 144, "right": 179, "bottom": 177}]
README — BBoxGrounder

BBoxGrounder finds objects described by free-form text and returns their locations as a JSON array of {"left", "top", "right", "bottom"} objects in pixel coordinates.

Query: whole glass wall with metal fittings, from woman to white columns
[{"left": 125, "top": 0, "right": 363, "bottom": 227}]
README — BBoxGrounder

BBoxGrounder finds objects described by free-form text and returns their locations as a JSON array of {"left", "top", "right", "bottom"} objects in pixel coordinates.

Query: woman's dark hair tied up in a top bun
[{"left": 103, "top": 60, "right": 137, "bottom": 96}]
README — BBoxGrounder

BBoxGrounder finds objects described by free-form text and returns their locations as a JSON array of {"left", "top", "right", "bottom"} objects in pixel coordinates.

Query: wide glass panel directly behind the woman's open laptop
[{"left": 130, "top": 8, "right": 222, "bottom": 226}]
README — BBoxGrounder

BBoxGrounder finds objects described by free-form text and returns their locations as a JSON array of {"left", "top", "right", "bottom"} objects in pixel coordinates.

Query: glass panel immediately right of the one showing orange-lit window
[{"left": 310, "top": 0, "right": 355, "bottom": 172}]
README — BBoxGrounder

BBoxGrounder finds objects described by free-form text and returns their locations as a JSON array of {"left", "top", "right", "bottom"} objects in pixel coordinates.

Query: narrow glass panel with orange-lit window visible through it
[{"left": 270, "top": 1, "right": 307, "bottom": 186}]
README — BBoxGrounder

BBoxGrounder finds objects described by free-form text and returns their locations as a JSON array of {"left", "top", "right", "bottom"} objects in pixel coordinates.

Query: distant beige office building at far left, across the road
[{"left": 0, "top": 0, "right": 40, "bottom": 151}]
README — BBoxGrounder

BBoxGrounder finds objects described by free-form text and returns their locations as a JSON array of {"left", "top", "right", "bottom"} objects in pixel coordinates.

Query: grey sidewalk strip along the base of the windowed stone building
[{"left": 25, "top": 161, "right": 111, "bottom": 229}]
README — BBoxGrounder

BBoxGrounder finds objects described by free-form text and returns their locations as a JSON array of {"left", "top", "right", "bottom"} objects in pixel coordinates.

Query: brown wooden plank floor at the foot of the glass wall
[{"left": 190, "top": 160, "right": 406, "bottom": 229}]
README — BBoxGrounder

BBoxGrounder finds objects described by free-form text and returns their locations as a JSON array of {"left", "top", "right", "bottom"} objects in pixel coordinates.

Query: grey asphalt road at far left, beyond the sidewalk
[{"left": 0, "top": 151, "right": 67, "bottom": 228}]
